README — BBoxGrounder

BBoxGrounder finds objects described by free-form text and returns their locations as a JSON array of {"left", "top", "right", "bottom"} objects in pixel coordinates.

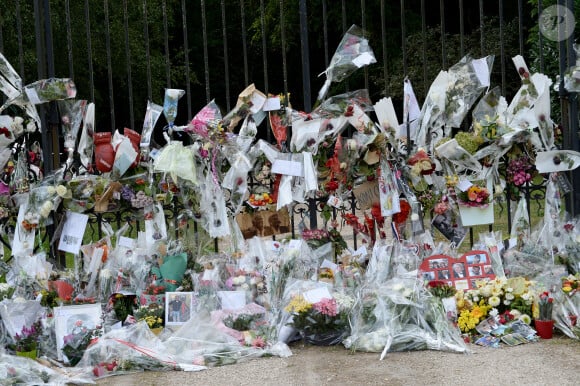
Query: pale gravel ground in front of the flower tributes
[{"left": 98, "top": 335, "right": 580, "bottom": 386}]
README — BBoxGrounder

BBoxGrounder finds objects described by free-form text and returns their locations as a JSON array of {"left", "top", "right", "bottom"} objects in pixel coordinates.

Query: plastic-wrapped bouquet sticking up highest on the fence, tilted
[{"left": 318, "top": 25, "right": 377, "bottom": 100}]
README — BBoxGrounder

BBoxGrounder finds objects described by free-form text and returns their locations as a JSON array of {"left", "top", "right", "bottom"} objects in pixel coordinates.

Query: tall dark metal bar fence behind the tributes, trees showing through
[{"left": 0, "top": 0, "right": 580, "bottom": 256}]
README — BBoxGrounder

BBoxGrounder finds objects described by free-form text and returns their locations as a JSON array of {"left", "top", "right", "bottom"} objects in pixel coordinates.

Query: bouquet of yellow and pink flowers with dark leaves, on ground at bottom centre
[{"left": 285, "top": 295, "right": 349, "bottom": 346}]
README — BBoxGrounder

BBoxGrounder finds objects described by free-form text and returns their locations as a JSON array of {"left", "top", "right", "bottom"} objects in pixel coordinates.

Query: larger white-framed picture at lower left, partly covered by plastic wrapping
[{"left": 54, "top": 303, "right": 103, "bottom": 362}]
